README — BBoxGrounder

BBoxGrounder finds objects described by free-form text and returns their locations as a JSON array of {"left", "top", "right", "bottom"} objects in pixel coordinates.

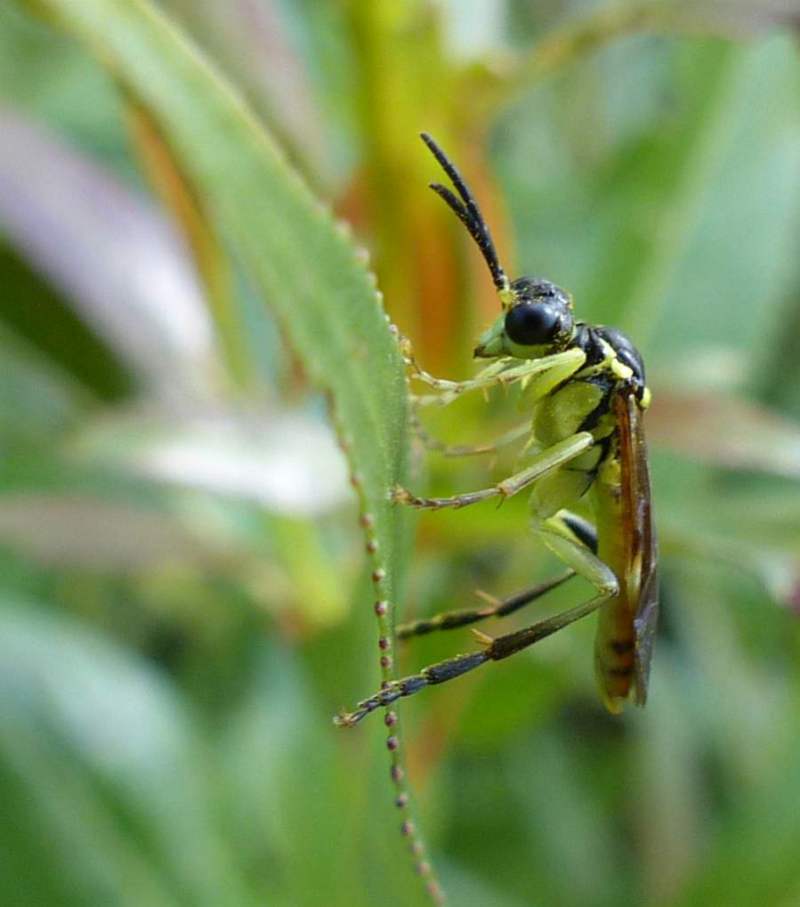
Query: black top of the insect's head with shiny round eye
[{"left": 505, "top": 277, "right": 573, "bottom": 346}]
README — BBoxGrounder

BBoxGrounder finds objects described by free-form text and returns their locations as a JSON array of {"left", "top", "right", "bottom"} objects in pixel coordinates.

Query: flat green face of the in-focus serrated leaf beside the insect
[{"left": 16, "top": 0, "right": 406, "bottom": 598}]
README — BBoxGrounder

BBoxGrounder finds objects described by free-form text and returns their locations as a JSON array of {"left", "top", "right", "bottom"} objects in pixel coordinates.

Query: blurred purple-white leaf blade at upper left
[{"left": 0, "top": 110, "right": 212, "bottom": 400}]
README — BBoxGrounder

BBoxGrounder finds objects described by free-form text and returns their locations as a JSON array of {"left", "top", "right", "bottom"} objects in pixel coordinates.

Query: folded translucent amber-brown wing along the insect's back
[{"left": 616, "top": 393, "right": 658, "bottom": 705}]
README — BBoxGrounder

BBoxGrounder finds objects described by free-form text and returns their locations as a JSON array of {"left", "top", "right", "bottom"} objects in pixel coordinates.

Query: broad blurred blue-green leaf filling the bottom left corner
[{"left": 0, "top": 599, "right": 256, "bottom": 907}]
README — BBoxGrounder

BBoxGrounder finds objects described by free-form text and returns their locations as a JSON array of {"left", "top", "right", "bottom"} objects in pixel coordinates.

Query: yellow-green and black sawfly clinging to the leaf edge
[{"left": 336, "top": 134, "right": 658, "bottom": 725}]
